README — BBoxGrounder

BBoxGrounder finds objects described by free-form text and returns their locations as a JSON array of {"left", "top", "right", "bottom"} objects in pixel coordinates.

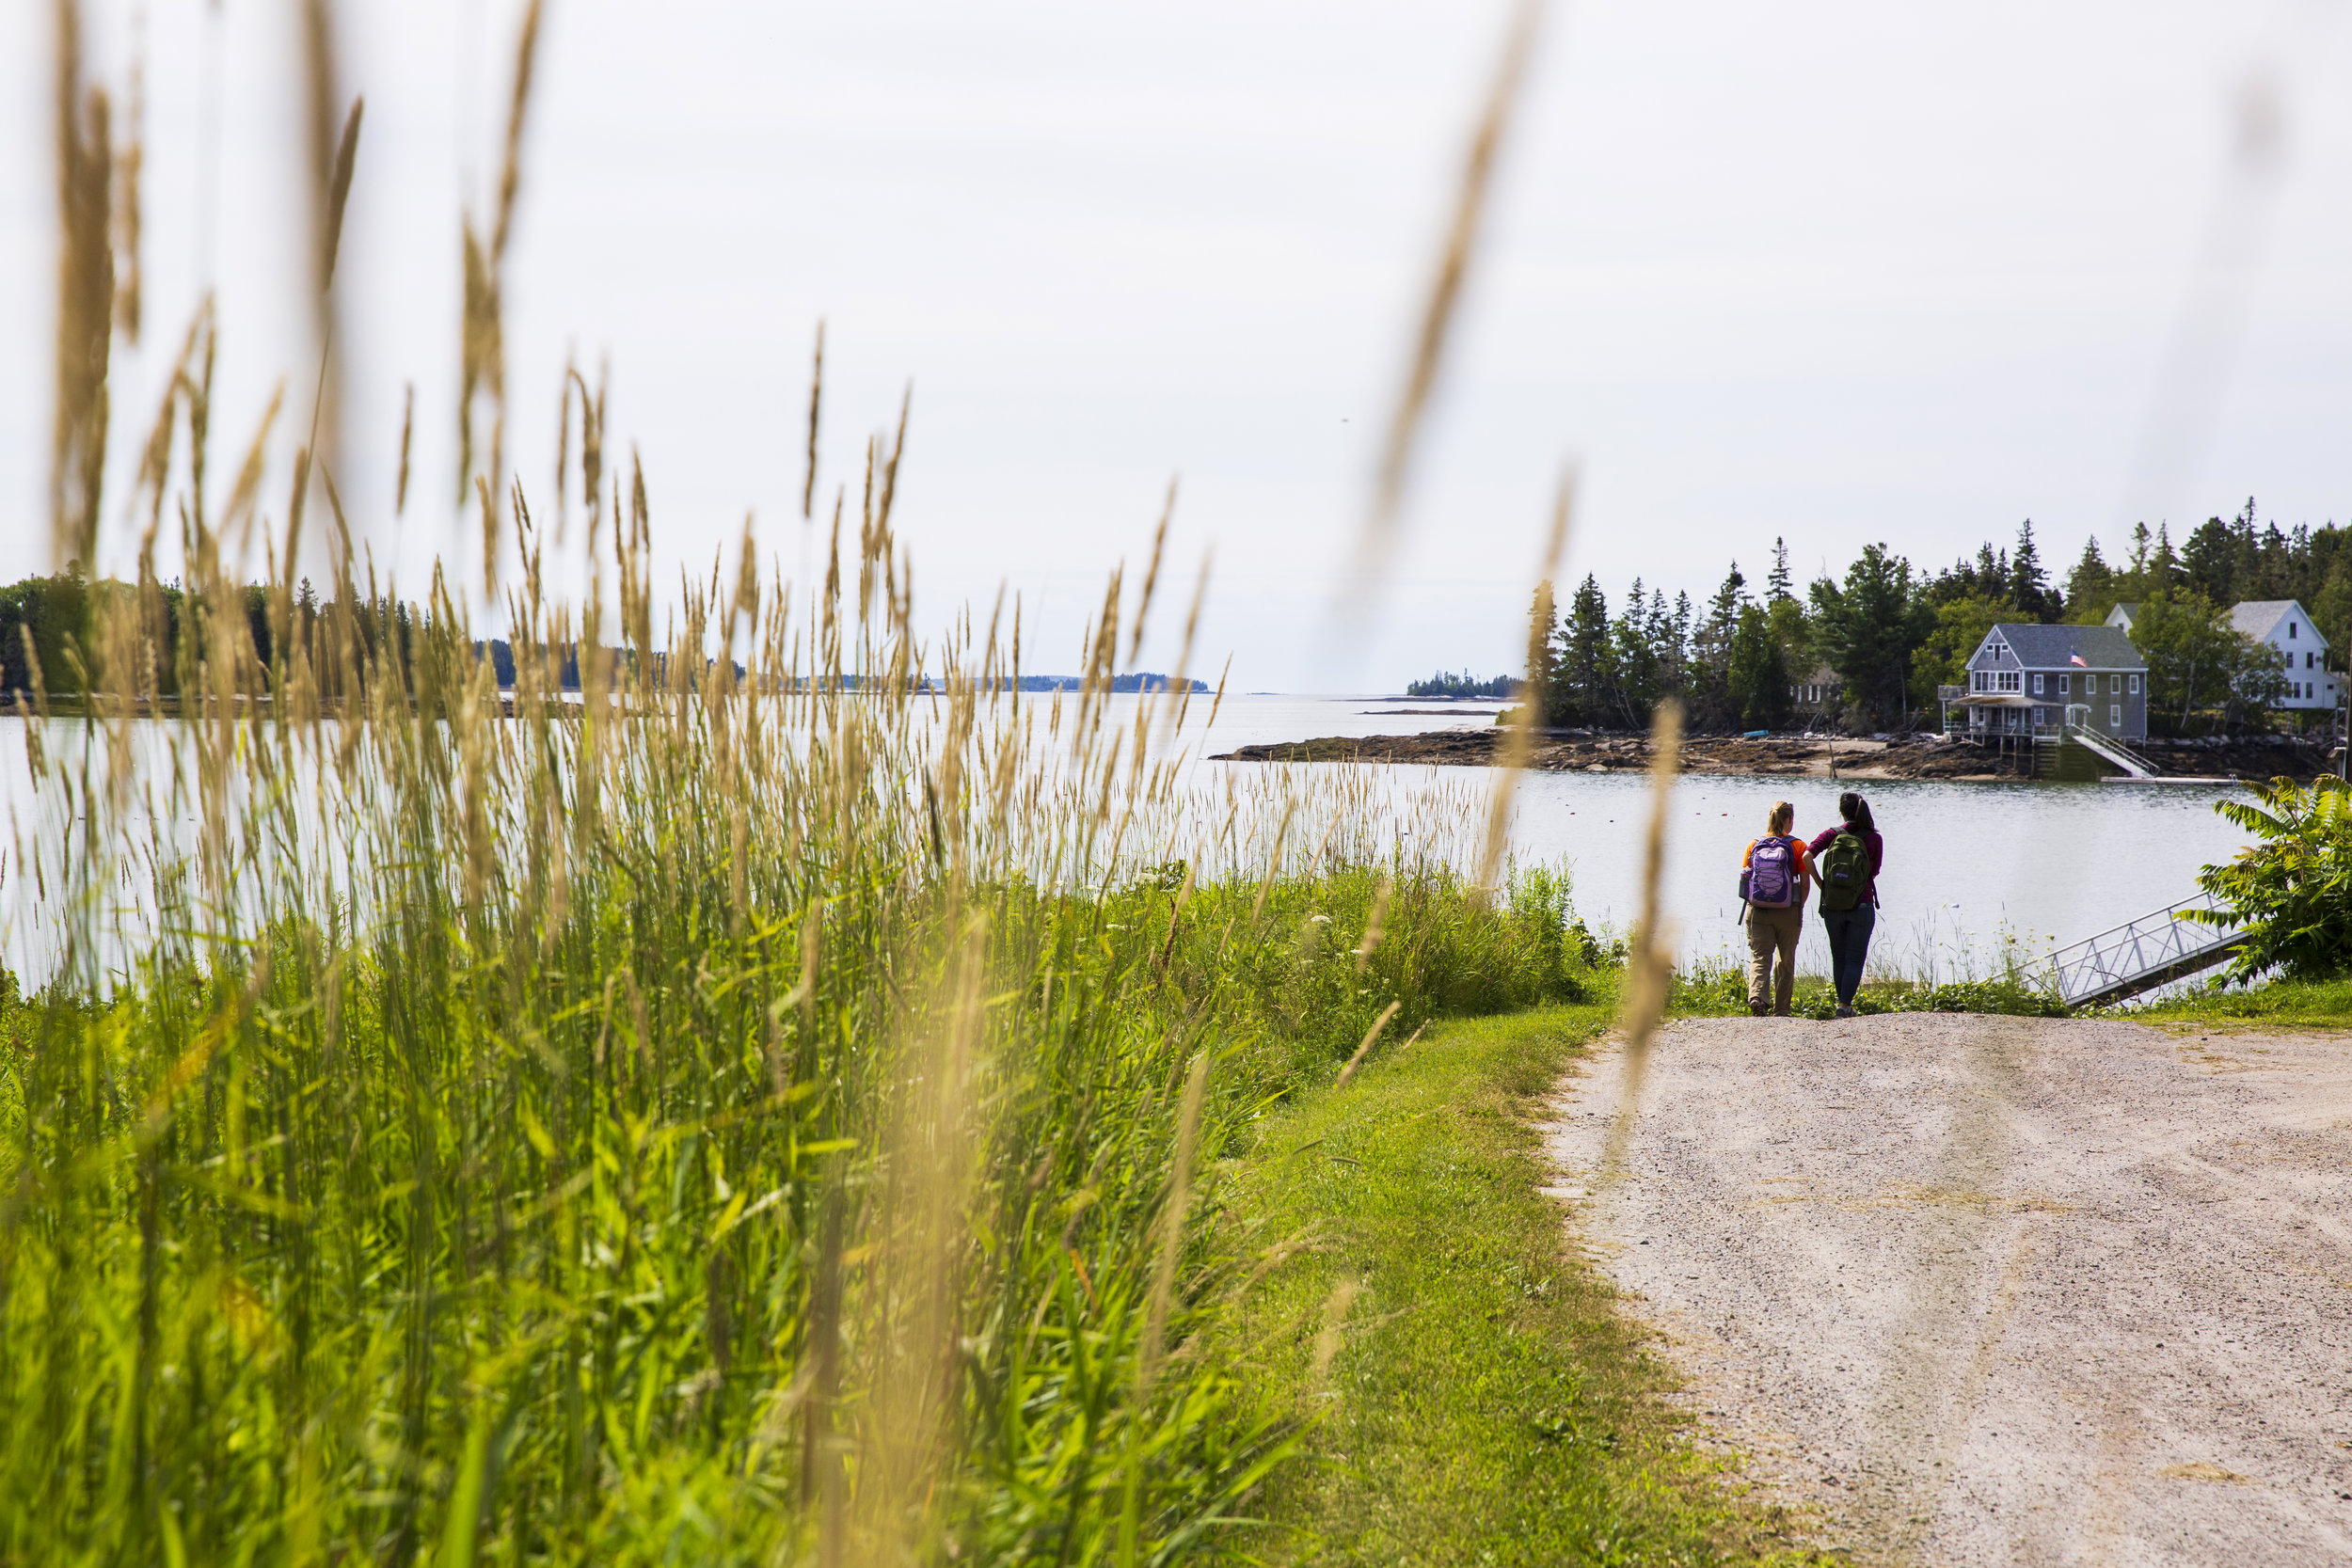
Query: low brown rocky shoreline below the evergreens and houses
[{"left": 1212, "top": 729, "right": 2328, "bottom": 783}]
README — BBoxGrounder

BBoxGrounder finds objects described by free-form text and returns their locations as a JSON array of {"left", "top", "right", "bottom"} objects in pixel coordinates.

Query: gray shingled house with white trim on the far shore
[{"left": 1950, "top": 621, "right": 2148, "bottom": 740}]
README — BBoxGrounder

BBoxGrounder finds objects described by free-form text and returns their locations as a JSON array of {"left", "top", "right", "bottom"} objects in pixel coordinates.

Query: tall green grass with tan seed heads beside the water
[{"left": 0, "top": 373, "right": 1581, "bottom": 1563}]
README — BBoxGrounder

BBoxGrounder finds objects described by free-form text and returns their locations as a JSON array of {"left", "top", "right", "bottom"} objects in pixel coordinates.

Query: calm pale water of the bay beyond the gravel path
[{"left": 0, "top": 696, "right": 2247, "bottom": 974}]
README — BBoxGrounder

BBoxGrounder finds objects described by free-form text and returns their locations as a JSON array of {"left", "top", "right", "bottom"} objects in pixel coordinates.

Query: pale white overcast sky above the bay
[{"left": 0, "top": 0, "right": 2352, "bottom": 691}]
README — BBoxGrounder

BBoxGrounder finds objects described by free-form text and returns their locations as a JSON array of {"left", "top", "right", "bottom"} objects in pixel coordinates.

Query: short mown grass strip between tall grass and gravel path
[{"left": 1216, "top": 1002, "right": 1811, "bottom": 1563}]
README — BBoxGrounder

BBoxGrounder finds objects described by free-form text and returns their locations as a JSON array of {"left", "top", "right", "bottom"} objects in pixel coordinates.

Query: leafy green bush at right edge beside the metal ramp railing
[{"left": 2187, "top": 778, "right": 2352, "bottom": 980}]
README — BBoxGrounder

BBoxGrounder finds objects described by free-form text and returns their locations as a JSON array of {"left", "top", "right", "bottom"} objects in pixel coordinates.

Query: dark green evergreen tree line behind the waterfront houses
[{"left": 1529, "top": 499, "right": 2352, "bottom": 734}]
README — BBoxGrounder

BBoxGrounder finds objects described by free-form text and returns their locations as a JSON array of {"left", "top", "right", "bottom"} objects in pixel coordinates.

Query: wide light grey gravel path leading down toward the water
[{"left": 1550, "top": 1016, "right": 2352, "bottom": 1566}]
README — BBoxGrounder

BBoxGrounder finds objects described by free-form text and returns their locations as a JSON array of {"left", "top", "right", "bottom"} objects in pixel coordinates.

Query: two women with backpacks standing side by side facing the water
[{"left": 1740, "top": 790, "right": 1886, "bottom": 1018}]
